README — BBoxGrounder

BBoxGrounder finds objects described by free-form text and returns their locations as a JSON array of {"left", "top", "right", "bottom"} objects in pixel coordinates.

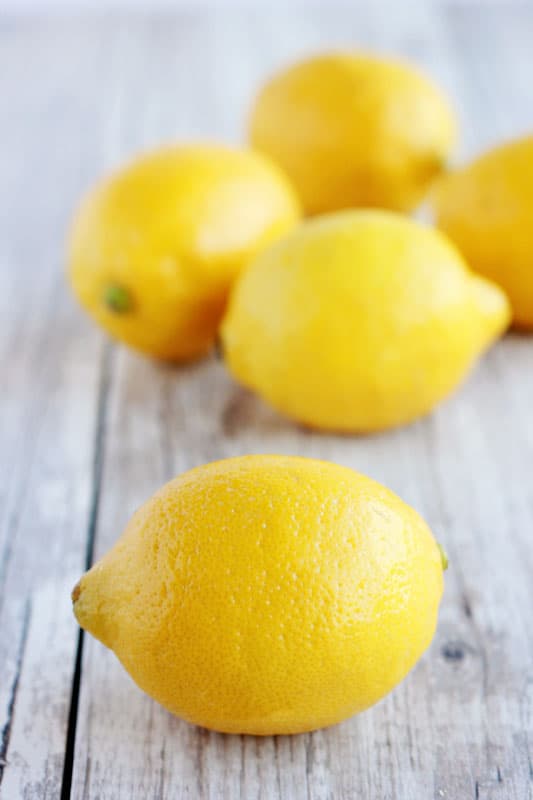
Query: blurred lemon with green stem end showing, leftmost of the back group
[{"left": 69, "top": 145, "right": 299, "bottom": 361}]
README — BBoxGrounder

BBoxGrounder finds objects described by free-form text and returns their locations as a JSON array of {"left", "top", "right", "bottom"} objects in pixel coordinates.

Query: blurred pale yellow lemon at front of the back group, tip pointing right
[{"left": 221, "top": 211, "right": 509, "bottom": 431}]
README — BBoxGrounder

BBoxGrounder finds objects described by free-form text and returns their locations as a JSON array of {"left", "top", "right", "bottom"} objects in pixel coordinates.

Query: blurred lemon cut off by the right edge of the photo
[{"left": 434, "top": 136, "right": 533, "bottom": 328}]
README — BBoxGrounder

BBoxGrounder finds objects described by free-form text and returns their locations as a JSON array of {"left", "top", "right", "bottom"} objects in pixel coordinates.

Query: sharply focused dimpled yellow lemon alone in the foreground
[{"left": 73, "top": 456, "right": 443, "bottom": 734}]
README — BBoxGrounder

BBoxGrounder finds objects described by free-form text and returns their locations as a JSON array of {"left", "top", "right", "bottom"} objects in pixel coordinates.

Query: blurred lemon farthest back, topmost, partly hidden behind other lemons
[{"left": 250, "top": 53, "right": 456, "bottom": 214}]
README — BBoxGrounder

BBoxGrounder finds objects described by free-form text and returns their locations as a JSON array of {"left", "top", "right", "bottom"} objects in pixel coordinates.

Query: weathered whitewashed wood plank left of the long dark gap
[{"left": 0, "top": 22, "right": 125, "bottom": 800}]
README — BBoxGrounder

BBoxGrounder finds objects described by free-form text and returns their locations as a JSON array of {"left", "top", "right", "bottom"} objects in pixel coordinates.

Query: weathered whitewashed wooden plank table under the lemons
[{"left": 0, "top": 3, "right": 533, "bottom": 800}]
